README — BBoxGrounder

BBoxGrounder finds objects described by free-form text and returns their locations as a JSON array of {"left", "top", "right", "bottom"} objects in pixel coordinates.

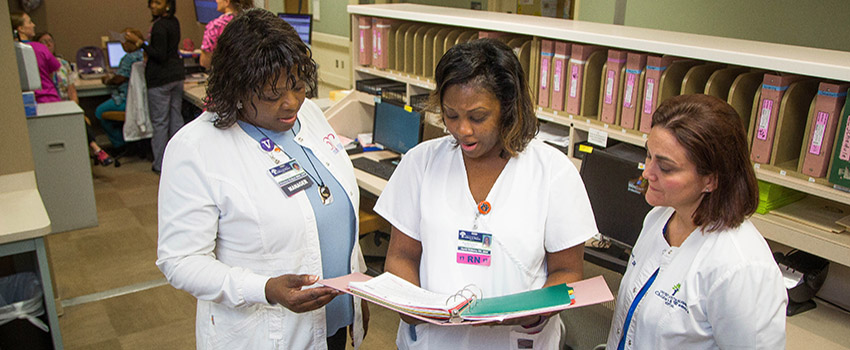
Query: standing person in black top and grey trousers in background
[{"left": 124, "top": 0, "right": 184, "bottom": 174}]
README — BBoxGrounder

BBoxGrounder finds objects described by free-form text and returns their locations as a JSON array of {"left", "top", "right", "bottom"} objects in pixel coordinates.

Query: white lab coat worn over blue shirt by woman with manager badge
[{"left": 157, "top": 100, "right": 366, "bottom": 349}]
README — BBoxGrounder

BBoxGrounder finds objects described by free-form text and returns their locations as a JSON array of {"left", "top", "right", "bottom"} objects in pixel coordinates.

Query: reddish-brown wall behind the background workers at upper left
[{"left": 7, "top": 0, "right": 204, "bottom": 61}]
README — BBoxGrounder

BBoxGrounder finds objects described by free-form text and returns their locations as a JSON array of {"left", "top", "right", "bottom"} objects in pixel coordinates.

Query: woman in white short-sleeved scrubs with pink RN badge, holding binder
[{"left": 375, "top": 39, "right": 597, "bottom": 349}]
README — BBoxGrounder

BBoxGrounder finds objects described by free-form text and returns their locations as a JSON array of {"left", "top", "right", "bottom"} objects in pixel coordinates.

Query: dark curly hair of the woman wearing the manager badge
[{"left": 204, "top": 8, "right": 317, "bottom": 129}]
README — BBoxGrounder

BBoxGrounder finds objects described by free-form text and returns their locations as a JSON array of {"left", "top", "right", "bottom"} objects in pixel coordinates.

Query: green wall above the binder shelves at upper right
[{"left": 578, "top": 0, "right": 850, "bottom": 51}]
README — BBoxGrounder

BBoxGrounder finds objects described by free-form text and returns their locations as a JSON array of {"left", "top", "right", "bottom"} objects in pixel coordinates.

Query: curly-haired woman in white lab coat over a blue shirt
[{"left": 157, "top": 9, "right": 368, "bottom": 349}]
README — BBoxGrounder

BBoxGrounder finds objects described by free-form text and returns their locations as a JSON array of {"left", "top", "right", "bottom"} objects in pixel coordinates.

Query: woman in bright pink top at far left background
[{"left": 9, "top": 12, "right": 62, "bottom": 103}]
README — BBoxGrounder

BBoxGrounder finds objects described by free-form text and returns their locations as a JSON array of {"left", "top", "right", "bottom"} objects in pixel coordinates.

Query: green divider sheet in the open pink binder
[{"left": 461, "top": 284, "right": 574, "bottom": 318}]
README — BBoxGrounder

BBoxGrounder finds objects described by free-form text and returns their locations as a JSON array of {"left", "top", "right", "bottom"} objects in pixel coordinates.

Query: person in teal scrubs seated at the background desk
[{"left": 94, "top": 28, "right": 144, "bottom": 149}]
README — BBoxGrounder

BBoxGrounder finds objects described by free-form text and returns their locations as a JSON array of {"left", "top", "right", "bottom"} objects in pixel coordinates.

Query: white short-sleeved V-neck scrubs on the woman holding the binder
[{"left": 375, "top": 136, "right": 597, "bottom": 349}]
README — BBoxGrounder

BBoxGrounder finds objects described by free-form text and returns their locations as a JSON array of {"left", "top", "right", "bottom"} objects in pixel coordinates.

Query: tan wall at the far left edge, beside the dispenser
[{"left": 0, "top": 1, "right": 35, "bottom": 175}]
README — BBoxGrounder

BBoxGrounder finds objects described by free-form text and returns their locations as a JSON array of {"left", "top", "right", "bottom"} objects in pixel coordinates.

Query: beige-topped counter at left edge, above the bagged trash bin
[{"left": 0, "top": 171, "right": 63, "bottom": 349}]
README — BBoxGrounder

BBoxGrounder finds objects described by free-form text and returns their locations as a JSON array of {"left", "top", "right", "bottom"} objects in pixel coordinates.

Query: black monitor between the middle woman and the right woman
[{"left": 581, "top": 150, "right": 652, "bottom": 248}]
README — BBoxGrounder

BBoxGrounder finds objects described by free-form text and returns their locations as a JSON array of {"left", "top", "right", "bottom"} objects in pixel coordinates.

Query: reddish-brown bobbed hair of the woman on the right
[{"left": 652, "top": 94, "right": 758, "bottom": 232}]
